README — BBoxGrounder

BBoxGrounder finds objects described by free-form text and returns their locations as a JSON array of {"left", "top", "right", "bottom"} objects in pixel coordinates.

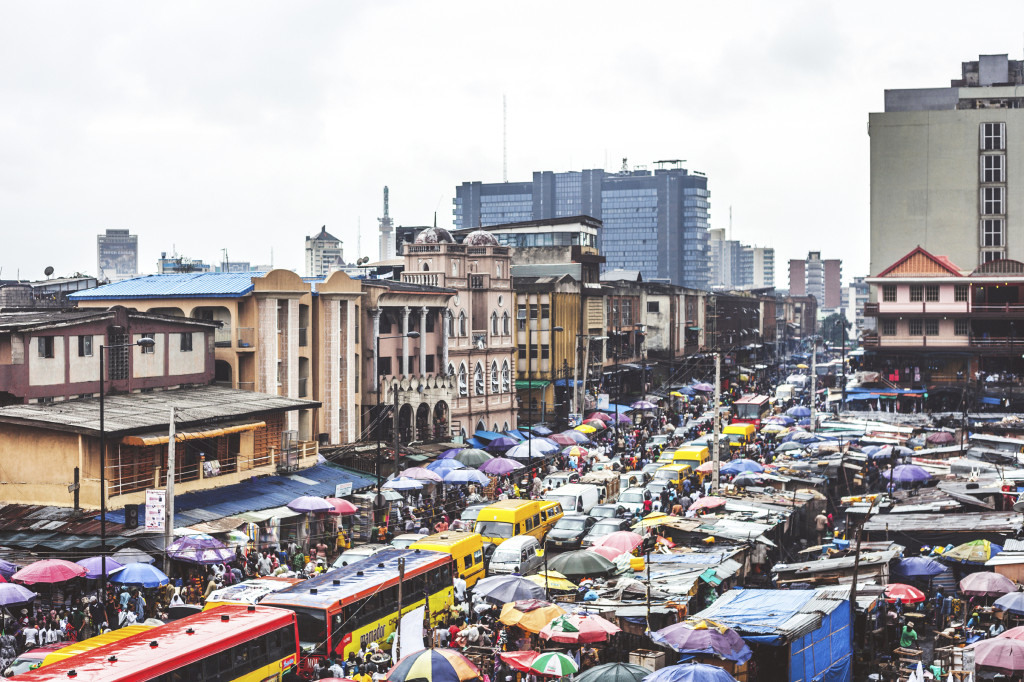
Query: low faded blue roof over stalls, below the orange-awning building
[{"left": 97, "top": 464, "right": 375, "bottom": 527}]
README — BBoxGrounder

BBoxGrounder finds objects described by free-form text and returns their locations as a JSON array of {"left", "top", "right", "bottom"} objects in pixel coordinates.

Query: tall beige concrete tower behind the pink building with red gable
[{"left": 868, "top": 54, "right": 1024, "bottom": 275}]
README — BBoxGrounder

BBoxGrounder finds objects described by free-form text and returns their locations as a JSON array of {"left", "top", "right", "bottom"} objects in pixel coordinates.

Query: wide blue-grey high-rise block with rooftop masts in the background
[{"left": 453, "top": 161, "right": 710, "bottom": 289}]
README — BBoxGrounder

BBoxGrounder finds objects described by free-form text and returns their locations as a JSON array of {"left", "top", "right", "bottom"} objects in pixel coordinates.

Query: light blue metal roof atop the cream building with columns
[{"left": 69, "top": 272, "right": 266, "bottom": 301}]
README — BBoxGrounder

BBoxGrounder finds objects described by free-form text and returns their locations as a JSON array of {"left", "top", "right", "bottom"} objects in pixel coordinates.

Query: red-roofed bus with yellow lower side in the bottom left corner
[{"left": 10, "top": 605, "right": 299, "bottom": 682}]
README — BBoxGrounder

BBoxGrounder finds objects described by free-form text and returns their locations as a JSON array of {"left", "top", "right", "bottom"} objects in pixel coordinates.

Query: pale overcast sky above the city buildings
[{"left": 0, "top": 0, "right": 1024, "bottom": 287}]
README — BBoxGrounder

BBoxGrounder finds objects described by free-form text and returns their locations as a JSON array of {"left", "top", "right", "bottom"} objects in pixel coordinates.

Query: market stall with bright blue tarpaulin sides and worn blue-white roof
[{"left": 695, "top": 588, "right": 852, "bottom": 682}]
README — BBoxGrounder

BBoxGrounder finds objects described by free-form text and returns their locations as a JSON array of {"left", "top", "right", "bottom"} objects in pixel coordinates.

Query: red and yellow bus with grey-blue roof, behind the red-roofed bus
[{"left": 260, "top": 549, "right": 455, "bottom": 679}]
